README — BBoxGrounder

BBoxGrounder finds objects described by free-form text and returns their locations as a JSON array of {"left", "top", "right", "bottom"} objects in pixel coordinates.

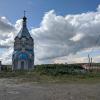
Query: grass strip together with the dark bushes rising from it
[{"left": 0, "top": 65, "right": 100, "bottom": 84}]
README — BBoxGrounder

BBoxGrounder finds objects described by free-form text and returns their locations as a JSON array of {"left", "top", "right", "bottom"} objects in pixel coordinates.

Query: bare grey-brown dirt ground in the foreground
[{"left": 0, "top": 79, "right": 100, "bottom": 100}]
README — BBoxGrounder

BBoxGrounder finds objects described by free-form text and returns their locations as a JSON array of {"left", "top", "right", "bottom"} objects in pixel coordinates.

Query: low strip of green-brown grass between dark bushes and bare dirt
[{"left": 0, "top": 71, "right": 100, "bottom": 84}]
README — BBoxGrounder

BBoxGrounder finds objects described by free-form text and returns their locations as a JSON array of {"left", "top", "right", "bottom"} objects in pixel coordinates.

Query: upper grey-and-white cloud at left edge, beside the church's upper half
[{"left": 0, "top": 17, "right": 16, "bottom": 48}]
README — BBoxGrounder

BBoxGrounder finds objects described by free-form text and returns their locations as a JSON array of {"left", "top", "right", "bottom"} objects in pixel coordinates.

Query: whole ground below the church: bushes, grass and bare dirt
[{"left": 0, "top": 66, "right": 100, "bottom": 100}]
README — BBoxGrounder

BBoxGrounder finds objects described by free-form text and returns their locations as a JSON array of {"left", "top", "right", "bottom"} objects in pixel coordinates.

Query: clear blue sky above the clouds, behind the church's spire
[{"left": 0, "top": 0, "right": 100, "bottom": 27}]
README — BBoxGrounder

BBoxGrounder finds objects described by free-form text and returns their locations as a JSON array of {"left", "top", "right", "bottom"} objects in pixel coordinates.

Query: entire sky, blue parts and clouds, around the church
[{"left": 0, "top": 0, "right": 100, "bottom": 64}]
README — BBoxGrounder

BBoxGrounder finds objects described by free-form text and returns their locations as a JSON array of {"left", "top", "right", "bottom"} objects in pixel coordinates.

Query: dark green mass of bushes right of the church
[{"left": 35, "top": 64, "right": 83, "bottom": 76}]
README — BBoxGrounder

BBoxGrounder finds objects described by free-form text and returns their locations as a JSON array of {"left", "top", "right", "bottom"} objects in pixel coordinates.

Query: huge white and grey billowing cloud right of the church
[{"left": 31, "top": 5, "right": 100, "bottom": 62}]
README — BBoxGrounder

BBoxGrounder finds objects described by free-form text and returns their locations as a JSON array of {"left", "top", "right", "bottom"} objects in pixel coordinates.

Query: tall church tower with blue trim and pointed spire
[{"left": 12, "top": 15, "right": 34, "bottom": 70}]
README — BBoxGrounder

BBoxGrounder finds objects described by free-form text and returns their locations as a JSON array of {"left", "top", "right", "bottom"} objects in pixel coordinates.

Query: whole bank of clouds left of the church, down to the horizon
[{"left": 0, "top": 17, "right": 17, "bottom": 64}]
